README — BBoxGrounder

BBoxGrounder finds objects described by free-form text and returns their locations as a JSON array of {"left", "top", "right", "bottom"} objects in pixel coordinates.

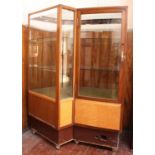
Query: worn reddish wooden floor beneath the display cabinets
[{"left": 22, "top": 130, "right": 133, "bottom": 155}]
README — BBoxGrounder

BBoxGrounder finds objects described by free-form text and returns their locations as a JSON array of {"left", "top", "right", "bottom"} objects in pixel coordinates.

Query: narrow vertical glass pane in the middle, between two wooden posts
[{"left": 60, "top": 9, "right": 74, "bottom": 99}]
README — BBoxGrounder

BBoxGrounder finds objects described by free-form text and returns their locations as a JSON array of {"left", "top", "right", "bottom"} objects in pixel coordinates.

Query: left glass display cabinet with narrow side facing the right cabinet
[{"left": 28, "top": 5, "right": 76, "bottom": 148}]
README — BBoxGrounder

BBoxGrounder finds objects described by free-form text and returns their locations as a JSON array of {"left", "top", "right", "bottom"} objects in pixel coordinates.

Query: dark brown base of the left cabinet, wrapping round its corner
[{"left": 29, "top": 116, "right": 73, "bottom": 149}]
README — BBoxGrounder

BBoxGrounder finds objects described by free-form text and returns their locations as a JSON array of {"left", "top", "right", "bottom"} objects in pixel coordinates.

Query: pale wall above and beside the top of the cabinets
[{"left": 22, "top": 0, "right": 133, "bottom": 29}]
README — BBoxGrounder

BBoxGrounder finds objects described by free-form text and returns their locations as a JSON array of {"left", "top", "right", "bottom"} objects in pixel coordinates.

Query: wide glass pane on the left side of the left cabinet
[{"left": 29, "top": 9, "right": 57, "bottom": 98}]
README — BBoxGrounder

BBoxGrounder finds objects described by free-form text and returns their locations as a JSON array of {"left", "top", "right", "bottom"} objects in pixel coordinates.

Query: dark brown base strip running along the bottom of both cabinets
[{"left": 29, "top": 116, "right": 119, "bottom": 151}]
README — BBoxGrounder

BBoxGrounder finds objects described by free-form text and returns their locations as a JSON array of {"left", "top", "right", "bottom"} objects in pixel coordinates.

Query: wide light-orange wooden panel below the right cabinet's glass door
[{"left": 75, "top": 99, "right": 121, "bottom": 131}]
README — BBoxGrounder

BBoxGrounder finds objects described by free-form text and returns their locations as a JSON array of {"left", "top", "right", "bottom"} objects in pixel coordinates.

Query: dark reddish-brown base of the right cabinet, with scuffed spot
[{"left": 74, "top": 126, "right": 119, "bottom": 147}]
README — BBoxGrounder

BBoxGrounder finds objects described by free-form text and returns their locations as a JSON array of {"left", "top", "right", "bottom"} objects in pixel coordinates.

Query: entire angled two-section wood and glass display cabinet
[{"left": 28, "top": 5, "right": 127, "bottom": 148}]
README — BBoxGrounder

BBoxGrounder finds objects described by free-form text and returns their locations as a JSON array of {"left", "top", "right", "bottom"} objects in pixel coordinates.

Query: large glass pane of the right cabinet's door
[{"left": 79, "top": 13, "right": 121, "bottom": 99}]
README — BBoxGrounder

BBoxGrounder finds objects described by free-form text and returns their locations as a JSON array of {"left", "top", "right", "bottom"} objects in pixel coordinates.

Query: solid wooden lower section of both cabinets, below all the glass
[{"left": 29, "top": 93, "right": 121, "bottom": 147}]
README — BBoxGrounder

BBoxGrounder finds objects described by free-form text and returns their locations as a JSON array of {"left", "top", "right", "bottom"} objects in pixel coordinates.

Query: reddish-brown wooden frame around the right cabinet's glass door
[{"left": 75, "top": 6, "right": 127, "bottom": 103}]
